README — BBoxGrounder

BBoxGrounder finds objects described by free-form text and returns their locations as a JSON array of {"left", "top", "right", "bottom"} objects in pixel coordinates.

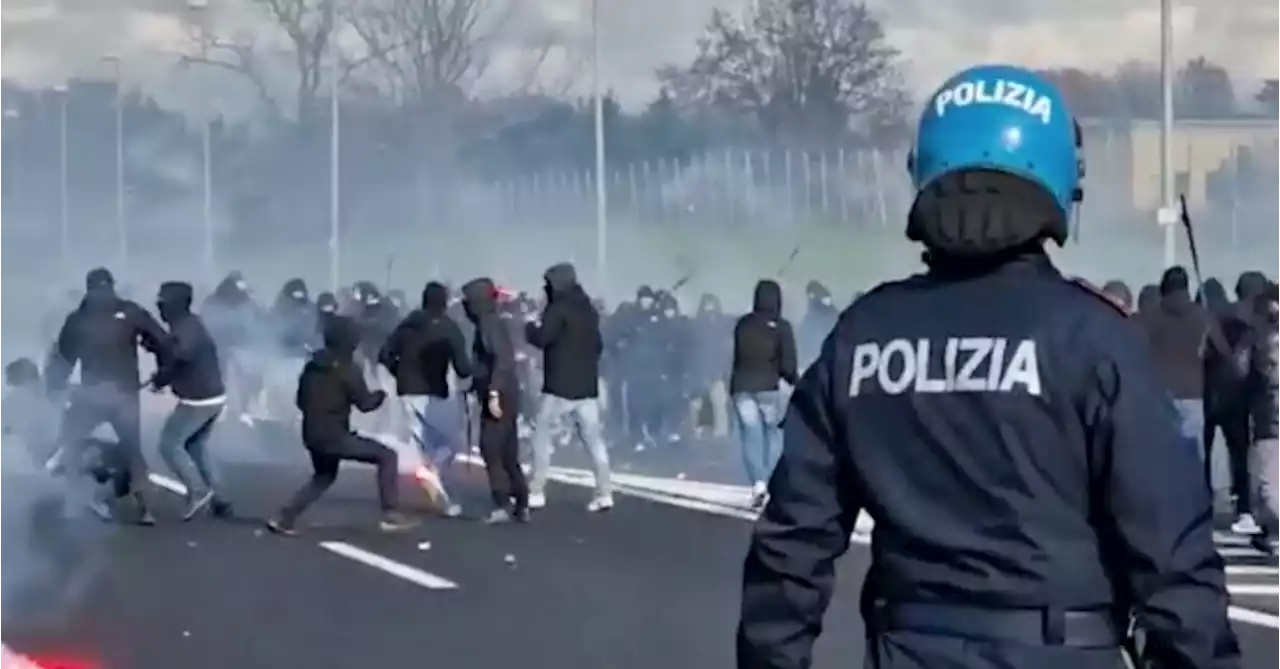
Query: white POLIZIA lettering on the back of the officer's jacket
[{"left": 849, "top": 336, "right": 1041, "bottom": 398}]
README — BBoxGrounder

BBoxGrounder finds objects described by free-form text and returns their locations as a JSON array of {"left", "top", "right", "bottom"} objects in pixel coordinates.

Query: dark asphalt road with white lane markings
[{"left": 0, "top": 447, "right": 1280, "bottom": 669}]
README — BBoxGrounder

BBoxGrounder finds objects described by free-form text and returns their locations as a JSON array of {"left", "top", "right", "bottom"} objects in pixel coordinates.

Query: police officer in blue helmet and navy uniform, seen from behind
[{"left": 737, "top": 67, "right": 1240, "bottom": 669}]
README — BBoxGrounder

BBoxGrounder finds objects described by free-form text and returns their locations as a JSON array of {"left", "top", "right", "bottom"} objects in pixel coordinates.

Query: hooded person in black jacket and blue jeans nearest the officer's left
[{"left": 728, "top": 279, "right": 800, "bottom": 508}]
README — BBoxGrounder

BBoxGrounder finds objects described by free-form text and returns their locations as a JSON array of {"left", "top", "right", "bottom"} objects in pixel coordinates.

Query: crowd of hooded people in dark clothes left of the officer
[{"left": 6, "top": 264, "right": 836, "bottom": 533}]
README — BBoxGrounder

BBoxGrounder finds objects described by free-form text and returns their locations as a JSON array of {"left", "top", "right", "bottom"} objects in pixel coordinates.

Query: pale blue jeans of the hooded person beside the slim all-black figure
[{"left": 529, "top": 393, "right": 613, "bottom": 498}]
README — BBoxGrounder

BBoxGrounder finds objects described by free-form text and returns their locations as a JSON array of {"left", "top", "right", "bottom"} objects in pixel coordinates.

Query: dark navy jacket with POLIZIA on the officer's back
[{"left": 737, "top": 256, "right": 1239, "bottom": 669}]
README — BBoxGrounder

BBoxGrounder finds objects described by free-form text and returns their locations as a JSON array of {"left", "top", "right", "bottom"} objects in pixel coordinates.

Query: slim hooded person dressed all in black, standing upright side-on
[{"left": 462, "top": 278, "right": 529, "bottom": 524}]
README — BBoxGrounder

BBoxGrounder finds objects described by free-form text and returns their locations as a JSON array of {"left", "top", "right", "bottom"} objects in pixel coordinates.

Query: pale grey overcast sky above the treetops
[{"left": 0, "top": 0, "right": 1280, "bottom": 113}]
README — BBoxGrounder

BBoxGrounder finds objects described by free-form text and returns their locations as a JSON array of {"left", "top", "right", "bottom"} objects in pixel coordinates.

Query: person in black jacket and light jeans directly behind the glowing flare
[{"left": 378, "top": 281, "right": 471, "bottom": 517}]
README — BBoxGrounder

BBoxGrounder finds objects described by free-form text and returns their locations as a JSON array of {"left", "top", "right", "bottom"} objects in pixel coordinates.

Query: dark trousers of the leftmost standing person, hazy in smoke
[{"left": 58, "top": 388, "right": 147, "bottom": 504}]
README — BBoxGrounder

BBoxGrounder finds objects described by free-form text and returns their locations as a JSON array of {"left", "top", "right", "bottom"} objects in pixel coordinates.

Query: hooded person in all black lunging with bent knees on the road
[{"left": 266, "top": 316, "right": 415, "bottom": 536}]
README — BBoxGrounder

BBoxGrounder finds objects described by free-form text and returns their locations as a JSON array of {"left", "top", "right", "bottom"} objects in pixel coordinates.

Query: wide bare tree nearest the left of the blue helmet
[{"left": 659, "top": 0, "right": 909, "bottom": 142}]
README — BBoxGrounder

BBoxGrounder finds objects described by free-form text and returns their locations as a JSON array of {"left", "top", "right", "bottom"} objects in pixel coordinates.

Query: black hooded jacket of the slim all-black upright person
[{"left": 462, "top": 278, "right": 520, "bottom": 397}]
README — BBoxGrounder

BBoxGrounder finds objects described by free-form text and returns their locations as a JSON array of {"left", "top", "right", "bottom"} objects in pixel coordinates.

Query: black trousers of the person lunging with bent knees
[{"left": 280, "top": 434, "right": 399, "bottom": 526}]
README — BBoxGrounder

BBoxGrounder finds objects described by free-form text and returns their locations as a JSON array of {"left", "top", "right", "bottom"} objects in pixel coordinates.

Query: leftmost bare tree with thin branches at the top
[{"left": 184, "top": 0, "right": 343, "bottom": 125}]
